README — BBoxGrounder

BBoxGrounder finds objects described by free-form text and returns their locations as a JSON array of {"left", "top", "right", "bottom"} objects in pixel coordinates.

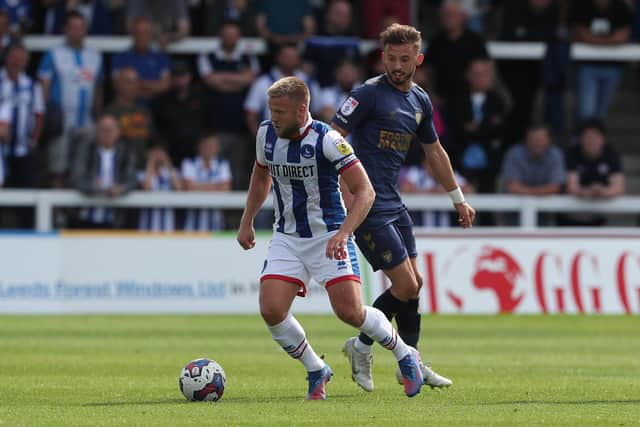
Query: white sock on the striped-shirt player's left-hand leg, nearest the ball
[{"left": 267, "top": 313, "right": 324, "bottom": 372}]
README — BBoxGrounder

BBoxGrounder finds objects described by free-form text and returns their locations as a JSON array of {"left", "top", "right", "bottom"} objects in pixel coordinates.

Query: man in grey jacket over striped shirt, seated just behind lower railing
[{"left": 72, "top": 114, "right": 136, "bottom": 229}]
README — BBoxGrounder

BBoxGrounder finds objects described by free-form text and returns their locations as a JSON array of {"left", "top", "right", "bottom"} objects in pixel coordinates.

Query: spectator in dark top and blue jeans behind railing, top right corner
[{"left": 569, "top": 0, "right": 631, "bottom": 121}]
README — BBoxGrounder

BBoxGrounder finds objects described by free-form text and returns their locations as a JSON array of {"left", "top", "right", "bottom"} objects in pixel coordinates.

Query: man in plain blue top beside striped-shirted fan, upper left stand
[{"left": 111, "top": 16, "right": 170, "bottom": 100}]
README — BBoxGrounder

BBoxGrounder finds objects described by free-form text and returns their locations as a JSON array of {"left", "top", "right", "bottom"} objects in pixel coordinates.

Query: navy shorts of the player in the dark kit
[{"left": 355, "top": 210, "right": 418, "bottom": 271}]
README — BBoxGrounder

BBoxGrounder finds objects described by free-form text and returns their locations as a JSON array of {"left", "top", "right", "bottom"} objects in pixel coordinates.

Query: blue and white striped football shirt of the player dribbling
[{"left": 256, "top": 116, "right": 358, "bottom": 237}]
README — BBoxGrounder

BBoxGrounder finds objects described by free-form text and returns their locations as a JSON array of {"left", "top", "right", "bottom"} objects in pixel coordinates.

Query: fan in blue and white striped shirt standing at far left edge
[{"left": 0, "top": 44, "right": 44, "bottom": 192}]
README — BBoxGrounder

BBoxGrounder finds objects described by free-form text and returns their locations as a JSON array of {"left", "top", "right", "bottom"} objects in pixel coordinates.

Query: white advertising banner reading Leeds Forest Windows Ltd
[{"left": 0, "top": 234, "right": 331, "bottom": 314}]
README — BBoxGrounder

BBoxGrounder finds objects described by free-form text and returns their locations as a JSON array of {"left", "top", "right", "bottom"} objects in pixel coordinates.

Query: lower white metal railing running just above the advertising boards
[{"left": 0, "top": 189, "right": 640, "bottom": 232}]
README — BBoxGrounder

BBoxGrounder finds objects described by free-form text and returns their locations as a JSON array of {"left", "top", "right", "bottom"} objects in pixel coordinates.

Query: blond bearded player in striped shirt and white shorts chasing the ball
[{"left": 238, "top": 77, "right": 423, "bottom": 400}]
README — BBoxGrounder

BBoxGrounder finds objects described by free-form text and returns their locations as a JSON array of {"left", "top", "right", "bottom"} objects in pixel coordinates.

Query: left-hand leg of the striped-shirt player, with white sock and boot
[{"left": 260, "top": 279, "right": 333, "bottom": 400}]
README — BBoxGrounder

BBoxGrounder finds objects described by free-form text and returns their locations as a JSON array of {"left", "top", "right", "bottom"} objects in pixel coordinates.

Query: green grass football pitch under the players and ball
[{"left": 0, "top": 316, "right": 640, "bottom": 427}]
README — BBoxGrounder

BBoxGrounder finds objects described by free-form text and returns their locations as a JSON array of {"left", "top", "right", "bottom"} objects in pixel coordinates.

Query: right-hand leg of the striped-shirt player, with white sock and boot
[{"left": 327, "top": 280, "right": 424, "bottom": 397}]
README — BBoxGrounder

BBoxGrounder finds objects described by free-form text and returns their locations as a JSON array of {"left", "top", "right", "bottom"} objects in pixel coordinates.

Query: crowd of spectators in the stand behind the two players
[{"left": 0, "top": 0, "right": 640, "bottom": 231}]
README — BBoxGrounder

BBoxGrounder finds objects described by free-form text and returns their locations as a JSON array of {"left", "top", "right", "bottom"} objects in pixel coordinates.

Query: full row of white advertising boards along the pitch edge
[{"left": 0, "top": 231, "right": 640, "bottom": 314}]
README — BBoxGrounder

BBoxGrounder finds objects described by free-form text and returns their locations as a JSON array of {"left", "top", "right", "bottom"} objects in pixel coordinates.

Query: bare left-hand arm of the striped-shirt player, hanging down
[{"left": 237, "top": 163, "right": 271, "bottom": 249}]
